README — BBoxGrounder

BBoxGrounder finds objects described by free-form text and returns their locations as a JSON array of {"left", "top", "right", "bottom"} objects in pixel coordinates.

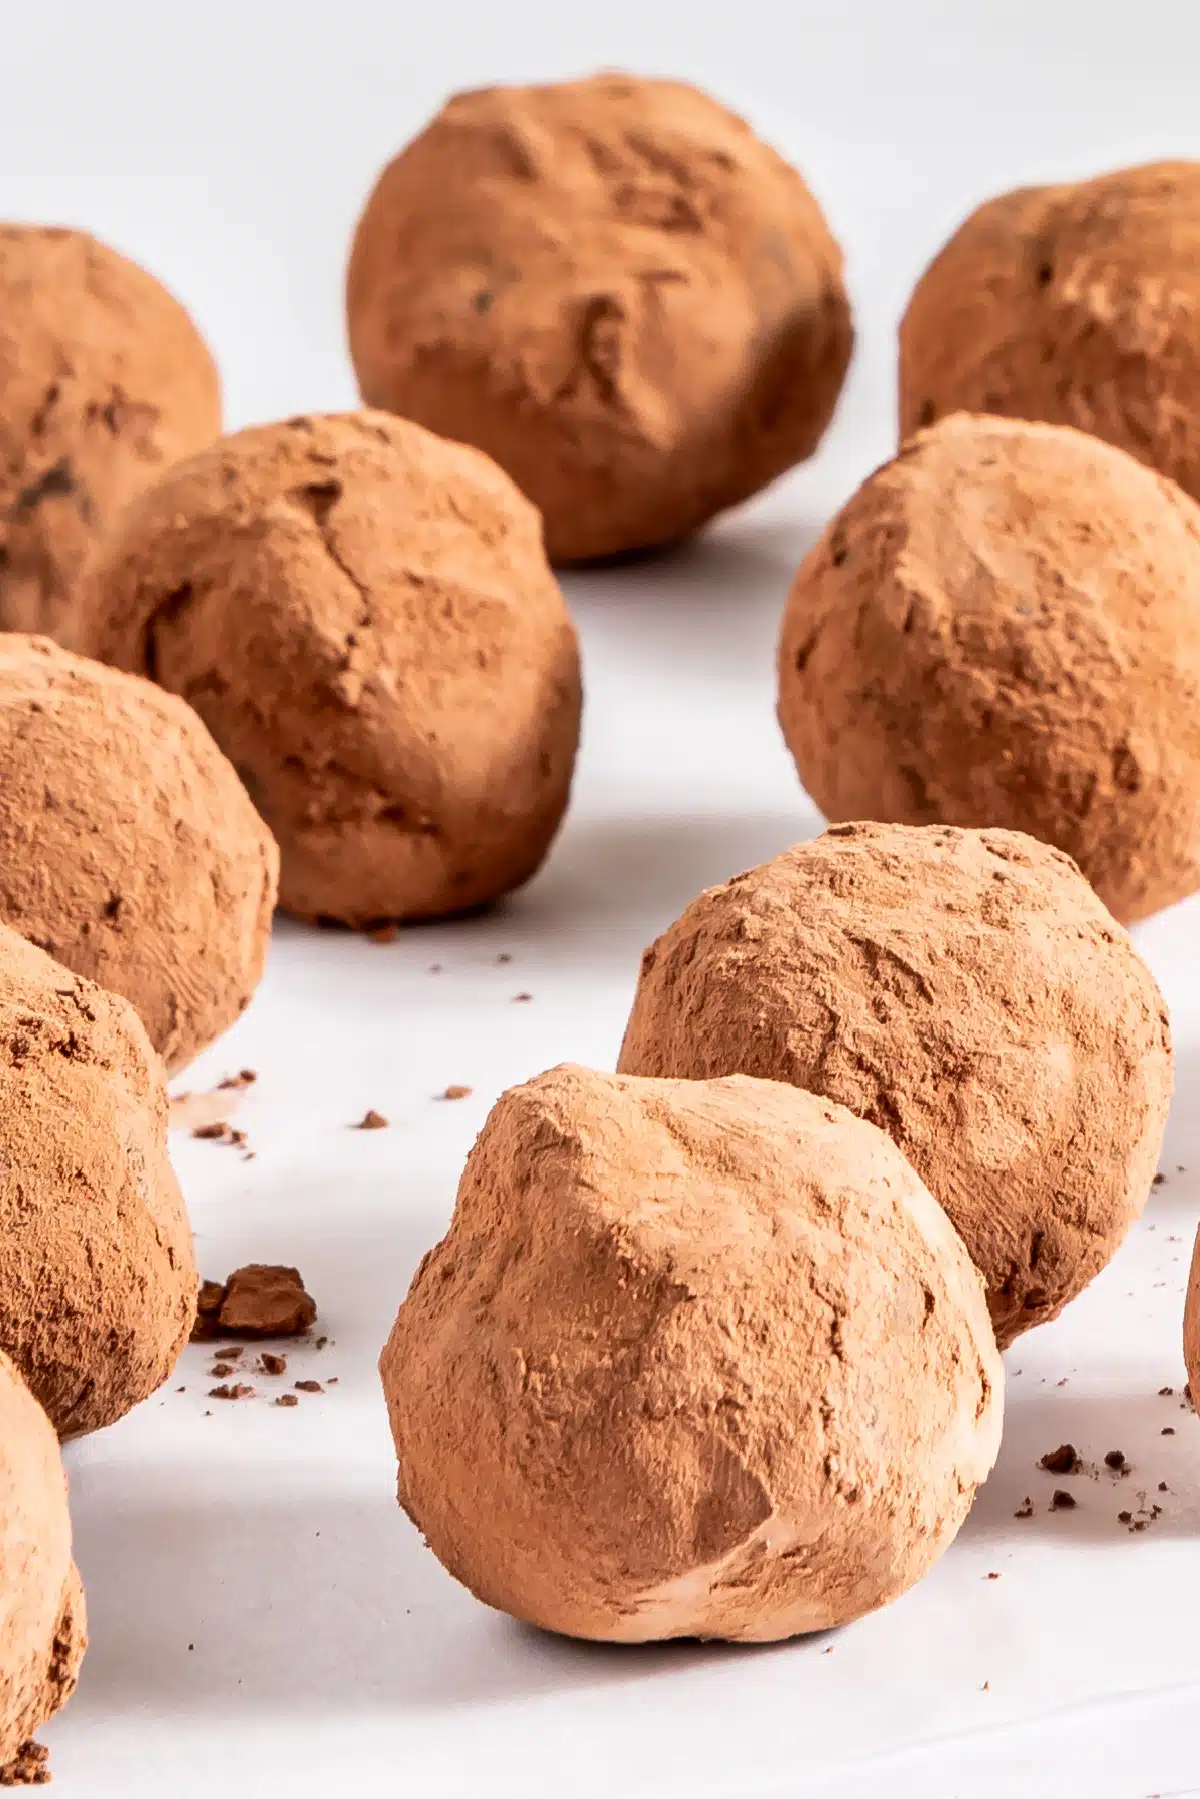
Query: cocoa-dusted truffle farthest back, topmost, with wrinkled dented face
[{"left": 347, "top": 74, "right": 853, "bottom": 561}]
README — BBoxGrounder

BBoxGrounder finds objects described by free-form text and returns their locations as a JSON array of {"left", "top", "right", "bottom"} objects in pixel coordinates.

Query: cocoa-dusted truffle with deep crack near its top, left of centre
[{"left": 75, "top": 412, "right": 581, "bottom": 925}]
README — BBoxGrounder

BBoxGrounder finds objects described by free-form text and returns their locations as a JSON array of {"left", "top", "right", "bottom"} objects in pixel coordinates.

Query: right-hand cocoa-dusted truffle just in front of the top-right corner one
[{"left": 779, "top": 414, "right": 1200, "bottom": 923}]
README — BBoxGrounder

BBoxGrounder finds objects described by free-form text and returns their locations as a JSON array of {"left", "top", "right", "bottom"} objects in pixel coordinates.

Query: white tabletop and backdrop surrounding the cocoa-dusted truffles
[{"left": 0, "top": 0, "right": 1200, "bottom": 1799}]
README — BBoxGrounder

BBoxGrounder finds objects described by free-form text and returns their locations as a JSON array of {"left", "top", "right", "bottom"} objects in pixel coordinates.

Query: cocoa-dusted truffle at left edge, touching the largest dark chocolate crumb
[{"left": 0, "top": 926, "right": 198, "bottom": 1432}]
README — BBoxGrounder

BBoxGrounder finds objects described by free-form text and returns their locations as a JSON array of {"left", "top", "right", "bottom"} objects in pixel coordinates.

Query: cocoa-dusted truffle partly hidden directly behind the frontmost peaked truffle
[{"left": 621, "top": 824, "right": 1171, "bottom": 1344}]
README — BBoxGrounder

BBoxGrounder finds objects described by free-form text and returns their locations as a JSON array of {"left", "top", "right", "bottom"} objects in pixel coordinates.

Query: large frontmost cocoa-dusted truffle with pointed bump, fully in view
[{"left": 381, "top": 1067, "right": 1002, "bottom": 1642}]
